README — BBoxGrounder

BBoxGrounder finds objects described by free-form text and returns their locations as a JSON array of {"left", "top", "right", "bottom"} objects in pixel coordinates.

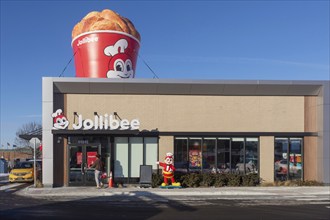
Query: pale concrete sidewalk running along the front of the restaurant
[{"left": 16, "top": 186, "right": 330, "bottom": 199}]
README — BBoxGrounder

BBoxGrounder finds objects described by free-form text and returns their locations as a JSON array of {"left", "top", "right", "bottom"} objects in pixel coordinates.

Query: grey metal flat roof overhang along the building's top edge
[{"left": 43, "top": 77, "right": 329, "bottom": 96}]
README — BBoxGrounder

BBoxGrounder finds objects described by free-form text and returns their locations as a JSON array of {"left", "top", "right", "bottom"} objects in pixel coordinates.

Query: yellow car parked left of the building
[{"left": 9, "top": 161, "right": 34, "bottom": 183}]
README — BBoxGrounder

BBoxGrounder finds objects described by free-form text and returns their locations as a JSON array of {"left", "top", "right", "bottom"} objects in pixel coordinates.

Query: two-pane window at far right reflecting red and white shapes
[{"left": 274, "top": 138, "right": 302, "bottom": 181}]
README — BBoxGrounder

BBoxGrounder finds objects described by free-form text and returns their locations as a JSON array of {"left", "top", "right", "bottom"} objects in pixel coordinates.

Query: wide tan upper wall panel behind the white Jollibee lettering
[{"left": 65, "top": 94, "right": 304, "bottom": 132}]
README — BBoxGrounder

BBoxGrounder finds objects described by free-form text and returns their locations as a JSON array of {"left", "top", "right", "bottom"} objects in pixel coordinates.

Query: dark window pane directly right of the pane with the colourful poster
[{"left": 202, "top": 138, "right": 216, "bottom": 172}]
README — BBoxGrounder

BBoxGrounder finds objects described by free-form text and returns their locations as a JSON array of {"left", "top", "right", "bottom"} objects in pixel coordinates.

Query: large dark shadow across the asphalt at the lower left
[{"left": 0, "top": 187, "right": 197, "bottom": 220}]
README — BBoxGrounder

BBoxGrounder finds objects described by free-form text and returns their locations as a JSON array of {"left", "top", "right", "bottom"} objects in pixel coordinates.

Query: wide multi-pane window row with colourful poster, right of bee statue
[{"left": 174, "top": 137, "right": 259, "bottom": 174}]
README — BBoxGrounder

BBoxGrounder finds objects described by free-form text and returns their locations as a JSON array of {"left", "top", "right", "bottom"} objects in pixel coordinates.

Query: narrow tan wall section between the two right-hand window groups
[{"left": 259, "top": 136, "right": 274, "bottom": 182}]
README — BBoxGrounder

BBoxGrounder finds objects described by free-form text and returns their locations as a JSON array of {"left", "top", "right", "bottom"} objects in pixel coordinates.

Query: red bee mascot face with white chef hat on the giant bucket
[{"left": 104, "top": 39, "right": 134, "bottom": 78}]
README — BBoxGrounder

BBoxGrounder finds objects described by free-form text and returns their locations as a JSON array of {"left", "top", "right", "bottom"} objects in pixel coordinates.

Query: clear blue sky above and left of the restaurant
[{"left": 0, "top": 0, "right": 329, "bottom": 148}]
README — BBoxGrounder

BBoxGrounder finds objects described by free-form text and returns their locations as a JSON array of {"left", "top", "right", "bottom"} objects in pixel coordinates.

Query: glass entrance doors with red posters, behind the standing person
[{"left": 68, "top": 144, "right": 101, "bottom": 186}]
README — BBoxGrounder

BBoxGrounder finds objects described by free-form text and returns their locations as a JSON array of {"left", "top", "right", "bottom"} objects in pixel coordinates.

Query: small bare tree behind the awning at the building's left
[{"left": 15, "top": 122, "right": 42, "bottom": 158}]
